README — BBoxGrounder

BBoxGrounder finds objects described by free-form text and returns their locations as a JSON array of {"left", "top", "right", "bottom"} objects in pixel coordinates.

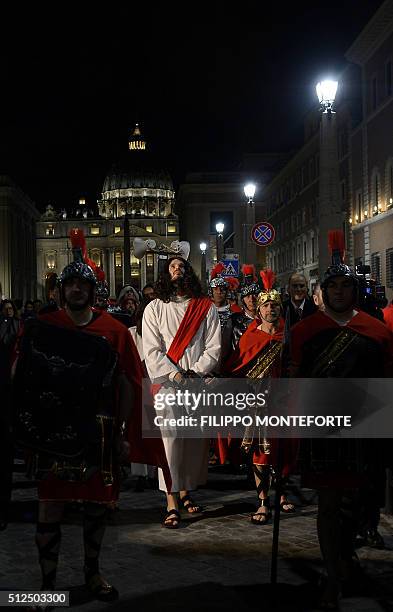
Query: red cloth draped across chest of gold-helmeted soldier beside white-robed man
[{"left": 224, "top": 319, "right": 284, "bottom": 376}]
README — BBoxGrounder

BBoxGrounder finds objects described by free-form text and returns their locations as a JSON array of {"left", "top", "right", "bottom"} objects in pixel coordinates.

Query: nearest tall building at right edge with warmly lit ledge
[{"left": 346, "top": 1, "right": 393, "bottom": 301}]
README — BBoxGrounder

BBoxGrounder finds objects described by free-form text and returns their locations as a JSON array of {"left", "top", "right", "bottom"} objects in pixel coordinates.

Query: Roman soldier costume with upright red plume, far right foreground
[{"left": 290, "top": 230, "right": 393, "bottom": 609}]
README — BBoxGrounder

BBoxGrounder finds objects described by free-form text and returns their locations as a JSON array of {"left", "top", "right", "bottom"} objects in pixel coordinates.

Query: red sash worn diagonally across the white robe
[{"left": 167, "top": 298, "right": 212, "bottom": 364}]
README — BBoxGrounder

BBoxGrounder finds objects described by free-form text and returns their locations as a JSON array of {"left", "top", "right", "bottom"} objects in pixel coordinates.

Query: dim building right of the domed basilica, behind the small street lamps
[{"left": 177, "top": 154, "right": 282, "bottom": 273}]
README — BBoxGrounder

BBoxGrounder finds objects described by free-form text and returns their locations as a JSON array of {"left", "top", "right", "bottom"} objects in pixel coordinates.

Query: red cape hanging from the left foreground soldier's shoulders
[{"left": 40, "top": 309, "right": 171, "bottom": 490}]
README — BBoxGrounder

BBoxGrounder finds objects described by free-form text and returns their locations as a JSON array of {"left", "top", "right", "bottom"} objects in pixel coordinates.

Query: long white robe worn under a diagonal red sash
[{"left": 142, "top": 297, "right": 221, "bottom": 492}]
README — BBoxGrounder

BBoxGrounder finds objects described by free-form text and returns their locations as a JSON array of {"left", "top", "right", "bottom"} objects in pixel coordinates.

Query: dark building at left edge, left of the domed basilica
[{"left": 0, "top": 175, "right": 39, "bottom": 301}]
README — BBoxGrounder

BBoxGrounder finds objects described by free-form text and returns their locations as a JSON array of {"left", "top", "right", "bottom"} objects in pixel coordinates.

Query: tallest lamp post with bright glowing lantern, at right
[{"left": 316, "top": 80, "right": 343, "bottom": 278}]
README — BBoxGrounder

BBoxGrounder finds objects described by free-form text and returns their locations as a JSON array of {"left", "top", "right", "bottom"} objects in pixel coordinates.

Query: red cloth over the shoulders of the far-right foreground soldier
[{"left": 291, "top": 310, "right": 393, "bottom": 376}]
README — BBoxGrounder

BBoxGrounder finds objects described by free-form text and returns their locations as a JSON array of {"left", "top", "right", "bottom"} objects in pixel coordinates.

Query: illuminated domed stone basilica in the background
[{"left": 37, "top": 125, "right": 179, "bottom": 297}]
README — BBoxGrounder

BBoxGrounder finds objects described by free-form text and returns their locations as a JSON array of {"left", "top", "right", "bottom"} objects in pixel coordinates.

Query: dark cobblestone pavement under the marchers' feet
[{"left": 0, "top": 469, "right": 393, "bottom": 612}]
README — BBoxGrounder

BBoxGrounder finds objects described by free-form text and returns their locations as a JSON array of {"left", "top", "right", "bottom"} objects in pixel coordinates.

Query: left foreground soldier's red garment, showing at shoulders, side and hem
[{"left": 38, "top": 309, "right": 170, "bottom": 503}]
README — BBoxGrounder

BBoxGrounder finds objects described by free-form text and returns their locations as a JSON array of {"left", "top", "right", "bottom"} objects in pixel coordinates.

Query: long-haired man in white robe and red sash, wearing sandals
[{"left": 142, "top": 256, "right": 221, "bottom": 529}]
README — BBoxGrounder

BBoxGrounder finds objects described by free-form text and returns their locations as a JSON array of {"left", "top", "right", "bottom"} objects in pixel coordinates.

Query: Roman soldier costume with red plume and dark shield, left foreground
[{"left": 13, "top": 230, "right": 170, "bottom": 601}]
